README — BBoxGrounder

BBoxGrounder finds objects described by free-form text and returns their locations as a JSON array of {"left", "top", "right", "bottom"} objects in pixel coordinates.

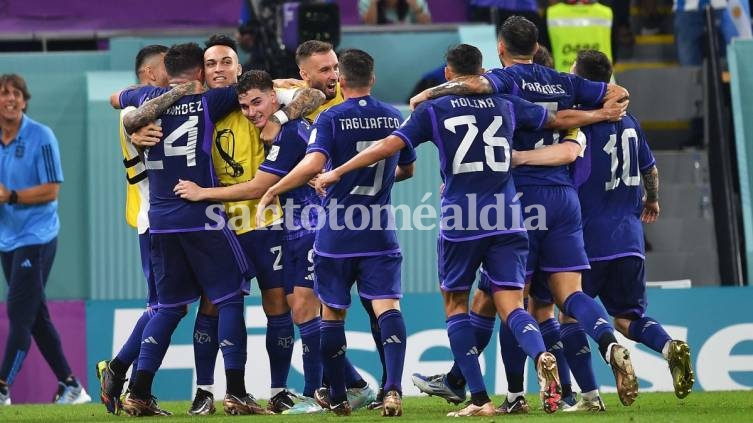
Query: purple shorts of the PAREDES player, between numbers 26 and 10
[{"left": 520, "top": 186, "right": 590, "bottom": 276}]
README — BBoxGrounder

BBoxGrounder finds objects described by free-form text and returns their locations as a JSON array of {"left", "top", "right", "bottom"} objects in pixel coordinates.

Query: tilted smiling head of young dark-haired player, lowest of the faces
[{"left": 235, "top": 70, "right": 280, "bottom": 128}]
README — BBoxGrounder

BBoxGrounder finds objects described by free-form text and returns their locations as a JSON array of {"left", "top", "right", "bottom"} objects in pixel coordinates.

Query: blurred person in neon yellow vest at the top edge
[{"left": 546, "top": 0, "right": 612, "bottom": 72}]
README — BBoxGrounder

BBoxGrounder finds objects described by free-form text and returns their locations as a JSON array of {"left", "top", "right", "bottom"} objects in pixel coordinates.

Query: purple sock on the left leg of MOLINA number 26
[{"left": 447, "top": 313, "right": 486, "bottom": 394}]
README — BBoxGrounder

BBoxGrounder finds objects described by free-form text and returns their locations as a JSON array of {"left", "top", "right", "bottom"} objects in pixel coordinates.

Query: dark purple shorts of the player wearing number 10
[{"left": 583, "top": 256, "right": 648, "bottom": 318}]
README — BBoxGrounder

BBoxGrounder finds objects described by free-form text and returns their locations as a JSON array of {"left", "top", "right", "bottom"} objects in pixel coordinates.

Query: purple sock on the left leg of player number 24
[{"left": 138, "top": 307, "right": 186, "bottom": 374}]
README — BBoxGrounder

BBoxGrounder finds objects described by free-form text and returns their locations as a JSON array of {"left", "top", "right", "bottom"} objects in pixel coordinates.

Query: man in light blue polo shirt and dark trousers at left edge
[{"left": 0, "top": 74, "right": 91, "bottom": 405}]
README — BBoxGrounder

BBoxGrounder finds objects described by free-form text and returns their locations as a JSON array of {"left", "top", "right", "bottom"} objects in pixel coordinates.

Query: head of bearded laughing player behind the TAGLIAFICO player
[{"left": 295, "top": 40, "right": 340, "bottom": 100}]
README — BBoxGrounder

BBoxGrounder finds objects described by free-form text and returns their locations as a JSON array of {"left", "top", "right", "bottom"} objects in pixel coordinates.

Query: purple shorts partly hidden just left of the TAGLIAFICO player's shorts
[{"left": 282, "top": 233, "right": 316, "bottom": 295}]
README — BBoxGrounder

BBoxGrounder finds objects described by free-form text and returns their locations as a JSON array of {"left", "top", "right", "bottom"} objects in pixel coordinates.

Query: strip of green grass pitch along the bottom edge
[{"left": 0, "top": 391, "right": 753, "bottom": 423}]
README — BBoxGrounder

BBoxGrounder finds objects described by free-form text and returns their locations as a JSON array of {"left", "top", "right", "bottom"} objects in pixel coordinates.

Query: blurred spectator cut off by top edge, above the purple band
[{"left": 358, "top": 0, "right": 431, "bottom": 25}]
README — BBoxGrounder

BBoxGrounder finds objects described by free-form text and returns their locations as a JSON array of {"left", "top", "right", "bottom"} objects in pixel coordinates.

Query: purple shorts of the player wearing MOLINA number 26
[{"left": 437, "top": 232, "right": 528, "bottom": 291}]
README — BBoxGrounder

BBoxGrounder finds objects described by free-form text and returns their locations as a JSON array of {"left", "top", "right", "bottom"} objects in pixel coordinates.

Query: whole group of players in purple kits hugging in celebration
[{"left": 97, "top": 16, "right": 694, "bottom": 417}]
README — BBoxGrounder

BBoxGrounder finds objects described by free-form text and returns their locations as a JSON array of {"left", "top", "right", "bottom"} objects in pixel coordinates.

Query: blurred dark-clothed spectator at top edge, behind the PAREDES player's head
[{"left": 469, "top": 0, "right": 550, "bottom": 48}]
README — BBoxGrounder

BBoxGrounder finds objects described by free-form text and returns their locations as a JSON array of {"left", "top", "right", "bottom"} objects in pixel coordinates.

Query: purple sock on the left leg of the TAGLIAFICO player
[{"left": 321, "top": 320, "right": 352, "bottom": 404}]
